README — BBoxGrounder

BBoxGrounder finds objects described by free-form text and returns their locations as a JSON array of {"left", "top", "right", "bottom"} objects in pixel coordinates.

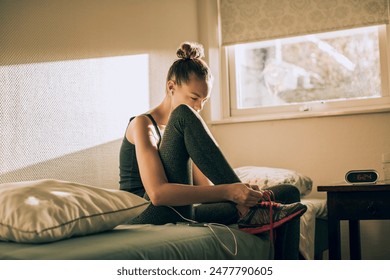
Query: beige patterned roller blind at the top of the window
[{"left": 219, "top": 0, "right": 389, "bottom": 46}]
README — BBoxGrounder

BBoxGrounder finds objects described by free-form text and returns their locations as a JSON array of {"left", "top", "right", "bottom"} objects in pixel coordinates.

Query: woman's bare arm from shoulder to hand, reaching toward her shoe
[{"left": 126, "top": 116, "right": 261, "bottom": 207}]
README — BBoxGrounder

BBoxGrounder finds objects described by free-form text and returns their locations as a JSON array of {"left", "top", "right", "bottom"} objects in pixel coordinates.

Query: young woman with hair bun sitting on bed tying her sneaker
[{"left": 120, "top": 42, "right": 306, "bottom": 259}]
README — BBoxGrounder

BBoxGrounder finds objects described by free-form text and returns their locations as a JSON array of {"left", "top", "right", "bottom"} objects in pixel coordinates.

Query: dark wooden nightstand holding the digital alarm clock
[{"left": 317, "top": 184, "right": 390, "bottom": 260}]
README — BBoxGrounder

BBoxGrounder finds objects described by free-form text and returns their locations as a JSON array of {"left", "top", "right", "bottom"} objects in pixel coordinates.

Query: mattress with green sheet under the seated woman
[{"left": 0, "top": 224, "right": 272, "bottom": 260}]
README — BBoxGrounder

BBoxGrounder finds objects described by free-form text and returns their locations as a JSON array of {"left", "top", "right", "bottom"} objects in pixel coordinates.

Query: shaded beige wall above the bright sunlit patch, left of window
[{"left": 0, "top": 0, "right": 198, "bottom": 107}]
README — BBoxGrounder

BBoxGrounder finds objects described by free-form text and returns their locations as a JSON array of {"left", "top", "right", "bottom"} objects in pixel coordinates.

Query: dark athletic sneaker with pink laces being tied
[{"left": 238, "top": 200, "right": 307, "bottom": 234}]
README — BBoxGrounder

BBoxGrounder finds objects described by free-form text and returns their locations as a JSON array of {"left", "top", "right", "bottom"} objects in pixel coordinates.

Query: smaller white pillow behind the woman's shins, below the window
[{"left": 234, "top": 166, "right": 313, "bottom": 196}]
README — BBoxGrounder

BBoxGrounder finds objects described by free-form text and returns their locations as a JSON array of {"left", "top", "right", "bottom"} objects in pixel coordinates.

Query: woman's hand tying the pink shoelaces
[{"left": 227, "top": 183, "right": 262, "bottom": 207}]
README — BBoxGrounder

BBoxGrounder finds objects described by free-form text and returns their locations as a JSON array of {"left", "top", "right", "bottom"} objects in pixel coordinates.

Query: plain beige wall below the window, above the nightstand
[{"left": 211, "top": 113, "right": 390, "bottom": 197}]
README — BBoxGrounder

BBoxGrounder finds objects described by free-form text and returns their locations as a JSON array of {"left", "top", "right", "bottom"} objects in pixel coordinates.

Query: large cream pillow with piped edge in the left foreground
[{"left": 0, "top": 179, "right": 149, "bottom": 243}]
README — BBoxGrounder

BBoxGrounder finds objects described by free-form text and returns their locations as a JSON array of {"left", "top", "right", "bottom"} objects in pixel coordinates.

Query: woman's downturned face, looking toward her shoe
[{"left": 168, "top": 76, "right": 211, "bottom": 112}]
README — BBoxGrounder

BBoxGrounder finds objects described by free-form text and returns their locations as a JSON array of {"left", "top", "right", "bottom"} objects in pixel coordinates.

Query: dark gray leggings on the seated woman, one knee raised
[{"left": 134, "top": 105, "right": 300, "bottom": 259}]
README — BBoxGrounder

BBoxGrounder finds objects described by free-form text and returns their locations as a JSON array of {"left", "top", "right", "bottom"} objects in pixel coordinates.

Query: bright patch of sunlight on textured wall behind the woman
[{"left": 0, "top": 54, "right": 149, "bottom": 174}]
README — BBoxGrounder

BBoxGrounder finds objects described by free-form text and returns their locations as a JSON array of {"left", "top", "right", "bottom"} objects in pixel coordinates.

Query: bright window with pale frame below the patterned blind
[{"left": 226, "top": 26, "right": 390, "bottom": 118}]
